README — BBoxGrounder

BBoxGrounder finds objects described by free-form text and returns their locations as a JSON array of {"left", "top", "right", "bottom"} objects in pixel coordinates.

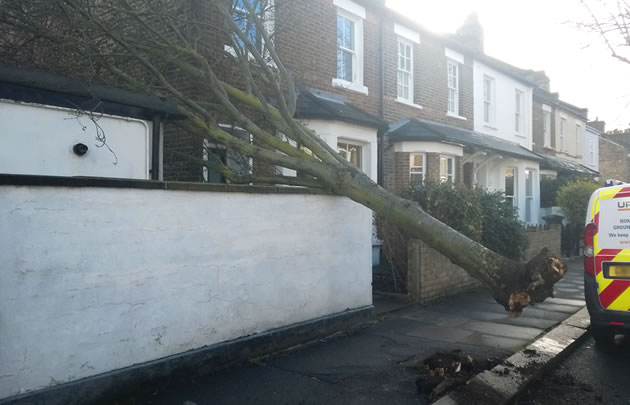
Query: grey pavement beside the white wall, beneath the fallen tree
[{"left": 112, "top": 258, "right": 585, "bottom": 405}]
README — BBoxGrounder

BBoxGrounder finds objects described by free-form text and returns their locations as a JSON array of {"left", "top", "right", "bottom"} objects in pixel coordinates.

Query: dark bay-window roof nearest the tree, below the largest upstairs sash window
[{"left": 295, "top": 89, "right": 387, "bottom": 128}]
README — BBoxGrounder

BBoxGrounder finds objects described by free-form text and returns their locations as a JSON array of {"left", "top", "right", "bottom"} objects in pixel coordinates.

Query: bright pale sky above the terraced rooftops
[{"left": 387, "top": 0, "right": 630, "bottom": 131}]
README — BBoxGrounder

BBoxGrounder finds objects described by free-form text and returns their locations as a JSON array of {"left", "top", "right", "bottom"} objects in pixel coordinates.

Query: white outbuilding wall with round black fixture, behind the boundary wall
[{"left": 0, "top": 100, "right": 152, "bottom": 179}]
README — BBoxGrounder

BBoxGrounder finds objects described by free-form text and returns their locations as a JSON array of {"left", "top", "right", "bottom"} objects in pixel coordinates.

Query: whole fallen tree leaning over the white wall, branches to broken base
[{"left": 0, "top": 0, "right": 566, "bottom": 315}]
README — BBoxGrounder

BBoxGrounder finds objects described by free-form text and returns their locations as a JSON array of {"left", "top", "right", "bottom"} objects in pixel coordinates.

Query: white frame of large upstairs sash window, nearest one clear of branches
[{"left": 332, "top": 0, "right": 368, "bottom": 95}]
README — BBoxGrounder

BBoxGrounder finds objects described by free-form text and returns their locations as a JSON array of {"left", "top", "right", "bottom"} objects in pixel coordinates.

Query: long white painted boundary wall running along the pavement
[{"left": 0, "top": 186, "right": 372, "bottom": 398}]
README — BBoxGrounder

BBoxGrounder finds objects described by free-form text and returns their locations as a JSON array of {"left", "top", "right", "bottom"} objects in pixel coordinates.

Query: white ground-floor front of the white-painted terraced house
[{"left": 477, "top": 157, "right": 540, "bottom": 224}]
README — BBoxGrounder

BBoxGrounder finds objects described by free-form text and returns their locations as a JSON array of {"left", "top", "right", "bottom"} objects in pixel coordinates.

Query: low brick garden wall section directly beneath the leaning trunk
[{"left": 407, "top": 240, "right": 480, "bottom": 303}]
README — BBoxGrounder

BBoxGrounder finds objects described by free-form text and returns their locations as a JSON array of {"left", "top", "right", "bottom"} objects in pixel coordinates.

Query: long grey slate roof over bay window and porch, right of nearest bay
[{"left": 389, "top": 118, "right": 542, "bottom": 161}]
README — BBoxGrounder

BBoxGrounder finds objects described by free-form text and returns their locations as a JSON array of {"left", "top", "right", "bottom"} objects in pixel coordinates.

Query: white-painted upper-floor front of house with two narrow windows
[{"left": 473, "top": 60, "right": 532, "bottom": 150}]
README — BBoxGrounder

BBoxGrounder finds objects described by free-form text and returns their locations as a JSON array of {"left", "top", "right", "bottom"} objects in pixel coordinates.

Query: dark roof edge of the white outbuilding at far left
[{"left": 0, "top": 65, "right": 184, "bottom": 119}]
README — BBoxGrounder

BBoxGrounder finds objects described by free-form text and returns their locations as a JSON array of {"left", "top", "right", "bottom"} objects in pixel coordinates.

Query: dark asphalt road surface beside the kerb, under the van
[{"left": 516, "top": 336, "right": 630, "bottom": 405}]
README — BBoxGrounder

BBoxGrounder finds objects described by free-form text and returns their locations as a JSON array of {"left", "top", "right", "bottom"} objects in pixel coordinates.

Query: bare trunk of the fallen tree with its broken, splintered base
[{"left": 320, "top": 166, "right": 566, "bottom": 316}]
